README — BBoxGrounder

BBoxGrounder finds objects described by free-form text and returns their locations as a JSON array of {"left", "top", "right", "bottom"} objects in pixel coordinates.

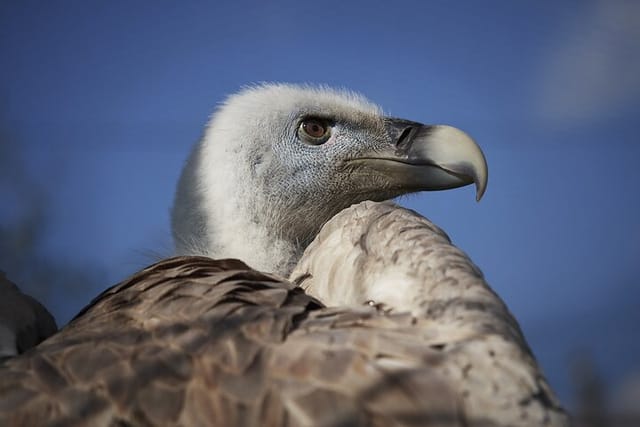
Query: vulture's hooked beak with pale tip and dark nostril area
[{"left": 355, "top": 118, "right": 489, "bottom": 201}]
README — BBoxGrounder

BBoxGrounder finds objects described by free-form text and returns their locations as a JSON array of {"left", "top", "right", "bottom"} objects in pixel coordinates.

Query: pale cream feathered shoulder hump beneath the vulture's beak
[{"left": 291, "top": 202, "right": 568, "bottom": 426}]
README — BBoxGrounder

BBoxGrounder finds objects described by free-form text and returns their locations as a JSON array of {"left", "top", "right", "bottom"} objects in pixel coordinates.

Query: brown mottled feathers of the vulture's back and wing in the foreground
[{"left": 0, "top": 205, "right": 565, "bottom": 426}]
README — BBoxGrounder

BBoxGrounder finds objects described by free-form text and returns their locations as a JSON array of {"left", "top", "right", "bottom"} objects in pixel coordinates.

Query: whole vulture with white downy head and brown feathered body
[{"left": 0, "top": 84, "right": 568, "bottom": 427}]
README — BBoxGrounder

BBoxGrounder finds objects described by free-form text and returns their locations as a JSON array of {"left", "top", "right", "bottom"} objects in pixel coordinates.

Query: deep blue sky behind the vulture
[{"left": 0, "top": 0, "right": 640, "bottom": 408}]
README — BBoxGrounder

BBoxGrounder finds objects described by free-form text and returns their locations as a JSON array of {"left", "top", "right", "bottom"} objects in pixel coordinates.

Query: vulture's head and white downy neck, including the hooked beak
[{"left": 172, "top": 84, "right": 487, "bottom": 274}]
